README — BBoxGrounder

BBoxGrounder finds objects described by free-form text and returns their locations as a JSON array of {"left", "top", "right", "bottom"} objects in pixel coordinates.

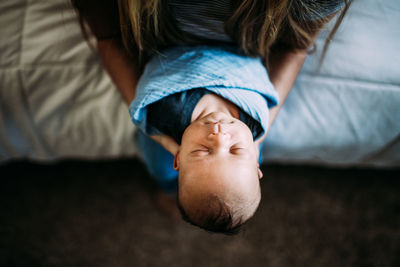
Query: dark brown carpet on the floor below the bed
[{"left": 0, "top": 160, "right": 400, "bottom": 267}]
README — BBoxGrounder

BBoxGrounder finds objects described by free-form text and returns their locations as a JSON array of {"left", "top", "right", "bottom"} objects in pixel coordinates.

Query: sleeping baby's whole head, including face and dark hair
[{"left": 174, "top": 112, "right": 262, "bottom": 233}]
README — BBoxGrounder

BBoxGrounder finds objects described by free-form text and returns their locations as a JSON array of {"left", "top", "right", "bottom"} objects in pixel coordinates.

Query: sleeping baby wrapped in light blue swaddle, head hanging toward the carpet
[{"left": 129, "top": 46, "right": 278, "bottom": 234}]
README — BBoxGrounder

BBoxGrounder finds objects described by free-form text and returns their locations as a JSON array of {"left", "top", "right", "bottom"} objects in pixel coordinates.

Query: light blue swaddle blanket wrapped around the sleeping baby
[{"left": 129, "top": 45, "right": 278, "bottom": 138}]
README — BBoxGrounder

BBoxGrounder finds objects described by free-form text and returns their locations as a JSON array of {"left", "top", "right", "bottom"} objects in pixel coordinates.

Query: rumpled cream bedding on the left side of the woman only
[{"left": 0, "top": 0, "right": 137, "bottom": 160}]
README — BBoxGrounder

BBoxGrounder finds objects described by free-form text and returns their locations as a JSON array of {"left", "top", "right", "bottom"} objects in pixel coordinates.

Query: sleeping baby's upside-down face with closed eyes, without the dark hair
[{"left": 176, "top": 112, "right": 262, "bottom": 220}]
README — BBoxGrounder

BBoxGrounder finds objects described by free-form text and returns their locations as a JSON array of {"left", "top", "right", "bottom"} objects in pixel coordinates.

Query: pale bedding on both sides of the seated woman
[{"left": 0, "top": 0, "right": 400, "bottom": 166}]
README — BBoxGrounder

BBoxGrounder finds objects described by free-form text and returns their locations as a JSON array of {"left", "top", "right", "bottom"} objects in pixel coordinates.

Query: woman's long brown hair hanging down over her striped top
[{"left": 118, "top": 0, "right": 351, "bottom": 63}]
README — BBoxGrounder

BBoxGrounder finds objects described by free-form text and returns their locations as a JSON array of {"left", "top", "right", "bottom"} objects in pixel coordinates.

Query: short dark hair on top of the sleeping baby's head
[{"left": 177, "top": 194, "right": 246, "bottom": 235}]
